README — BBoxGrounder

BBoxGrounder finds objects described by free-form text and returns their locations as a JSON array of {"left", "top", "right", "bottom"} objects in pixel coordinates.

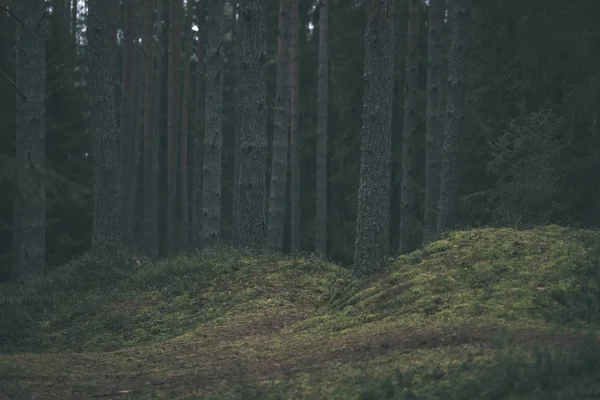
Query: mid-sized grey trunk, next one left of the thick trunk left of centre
[{"left": 202, "top": 0, "right": 224, "bottom": 247}]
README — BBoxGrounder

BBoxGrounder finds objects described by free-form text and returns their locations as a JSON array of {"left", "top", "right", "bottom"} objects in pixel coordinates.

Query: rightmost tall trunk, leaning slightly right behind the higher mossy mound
[{"left": 437, "top": 0, "right": 470, "bottom": 233}]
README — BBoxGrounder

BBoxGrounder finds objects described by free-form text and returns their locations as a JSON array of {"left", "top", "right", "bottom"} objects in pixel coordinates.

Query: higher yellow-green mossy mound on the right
[{"left": 302, "top": 226, "right": 600, "bottom": 330}]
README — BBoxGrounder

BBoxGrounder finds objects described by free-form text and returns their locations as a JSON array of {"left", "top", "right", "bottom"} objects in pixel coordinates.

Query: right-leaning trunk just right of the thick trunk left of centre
[{"left": 267, "top": 0, "right": 291, "bottom": 250}]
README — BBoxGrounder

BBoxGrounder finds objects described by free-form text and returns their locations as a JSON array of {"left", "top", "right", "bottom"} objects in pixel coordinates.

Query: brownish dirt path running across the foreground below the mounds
[{"left": 0, "top": 319, "right": 584, "bottom": 400}]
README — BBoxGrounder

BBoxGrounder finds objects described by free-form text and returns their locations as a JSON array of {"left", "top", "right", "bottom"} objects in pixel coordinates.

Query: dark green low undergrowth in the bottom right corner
[{"left": 344, "top": 336, "right": 600, "bottom": 400}]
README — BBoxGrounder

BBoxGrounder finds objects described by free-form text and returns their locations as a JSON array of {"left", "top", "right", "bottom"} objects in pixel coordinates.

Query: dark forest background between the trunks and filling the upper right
[{"left": 0, "top": 0, "right": 600, "bottom": 280}]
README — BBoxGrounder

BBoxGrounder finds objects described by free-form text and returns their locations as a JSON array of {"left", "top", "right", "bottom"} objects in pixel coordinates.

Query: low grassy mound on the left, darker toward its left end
[{"left": 0, "top": 248, "right": 349, "bottom": 352}]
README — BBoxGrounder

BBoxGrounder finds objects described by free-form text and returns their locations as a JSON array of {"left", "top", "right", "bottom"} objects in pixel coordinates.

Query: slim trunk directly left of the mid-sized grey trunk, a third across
[{"left": 192, "top": 0, "right": 206, "bottom": 249}]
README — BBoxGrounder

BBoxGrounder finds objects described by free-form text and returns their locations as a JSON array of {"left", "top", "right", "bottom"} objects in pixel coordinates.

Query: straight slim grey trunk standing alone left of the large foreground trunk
[{"left": 315, "top": 0, "right": 329, "bottom": 257}]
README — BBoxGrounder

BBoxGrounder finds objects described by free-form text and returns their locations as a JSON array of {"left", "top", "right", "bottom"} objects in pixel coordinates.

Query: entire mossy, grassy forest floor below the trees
[{"left": 0, "top": 226, "right": 600, "bottom": 399}]
